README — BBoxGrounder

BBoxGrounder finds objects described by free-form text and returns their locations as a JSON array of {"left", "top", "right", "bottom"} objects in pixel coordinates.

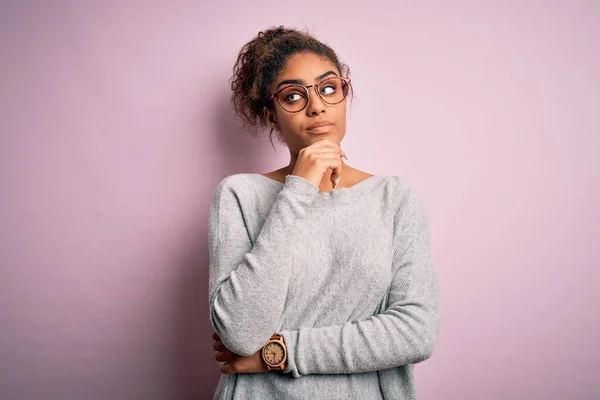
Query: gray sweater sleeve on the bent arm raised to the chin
[{"left": 208, "top": 175, "right": 319, "bottom": 356}]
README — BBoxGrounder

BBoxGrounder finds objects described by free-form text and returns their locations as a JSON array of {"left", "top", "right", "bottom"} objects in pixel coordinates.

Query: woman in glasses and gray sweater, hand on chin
[{"left": 209, "top": 27, "right": 438, "bottom": 400}]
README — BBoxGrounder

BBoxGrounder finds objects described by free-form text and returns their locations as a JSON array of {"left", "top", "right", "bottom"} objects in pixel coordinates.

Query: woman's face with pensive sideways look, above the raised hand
[{"left": 264, "top": 53, "right": 347, "bottom": 153}]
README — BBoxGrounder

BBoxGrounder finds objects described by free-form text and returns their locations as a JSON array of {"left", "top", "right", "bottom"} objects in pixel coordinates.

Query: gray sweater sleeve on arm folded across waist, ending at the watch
[{"left": 280, "top": 190, "right": 438, "bottom": 378}]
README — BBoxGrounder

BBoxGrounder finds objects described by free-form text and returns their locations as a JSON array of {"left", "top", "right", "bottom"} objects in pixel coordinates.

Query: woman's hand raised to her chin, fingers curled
[{"left": 292, "top": 139, "right": 346, "bottom": 186}]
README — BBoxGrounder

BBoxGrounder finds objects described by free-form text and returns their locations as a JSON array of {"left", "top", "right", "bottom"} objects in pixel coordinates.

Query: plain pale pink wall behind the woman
[{"left": 0, "top": 0, "right": 600, "bottom": 400}]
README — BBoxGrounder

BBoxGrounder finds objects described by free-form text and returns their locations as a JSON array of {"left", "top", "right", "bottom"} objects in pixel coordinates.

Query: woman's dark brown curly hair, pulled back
[{"left": 230, "top": 26, "right": 350, "bottom": 143}]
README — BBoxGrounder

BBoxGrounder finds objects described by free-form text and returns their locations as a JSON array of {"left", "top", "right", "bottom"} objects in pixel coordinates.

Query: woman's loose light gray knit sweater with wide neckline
[{"left": 209, "top": 173, "right": 438, "bottom": 400}]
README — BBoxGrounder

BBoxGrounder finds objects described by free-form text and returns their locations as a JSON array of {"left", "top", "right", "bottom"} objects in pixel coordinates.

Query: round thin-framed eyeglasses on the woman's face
[{"left": 269, "top": 76, "right": 350, "bottom": 113}]
